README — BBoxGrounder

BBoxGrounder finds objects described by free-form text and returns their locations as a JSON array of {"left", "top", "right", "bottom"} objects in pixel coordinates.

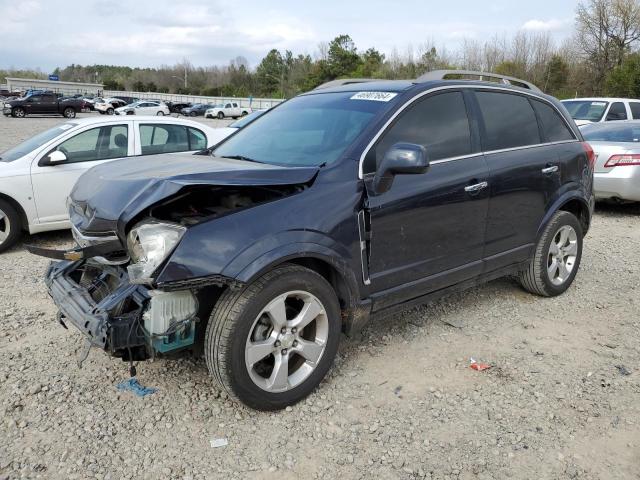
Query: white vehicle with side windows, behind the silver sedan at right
[{"left": 562, "top": 98, "right": 640, "bottom": 127}]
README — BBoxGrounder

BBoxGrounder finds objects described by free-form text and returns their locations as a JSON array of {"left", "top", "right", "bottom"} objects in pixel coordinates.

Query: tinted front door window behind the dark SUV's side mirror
[{"left": 363, "top": 92, "right": 471, "bottom": 173}]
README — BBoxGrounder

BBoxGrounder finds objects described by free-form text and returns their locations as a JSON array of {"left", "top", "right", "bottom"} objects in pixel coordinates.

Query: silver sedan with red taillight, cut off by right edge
[{"left": 580, "top": 121, "right": 640, "bottom": 202}]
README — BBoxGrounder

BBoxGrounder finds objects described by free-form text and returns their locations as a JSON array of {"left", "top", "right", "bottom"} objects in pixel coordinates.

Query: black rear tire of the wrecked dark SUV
[{"left": 519, "top": 211, "right": 583, "bottom": 297}]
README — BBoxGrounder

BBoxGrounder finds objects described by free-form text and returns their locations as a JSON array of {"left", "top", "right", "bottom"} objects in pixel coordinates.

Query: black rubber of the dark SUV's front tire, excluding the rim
[{"left": 204, "top": 264, "right": 341, "bottom": 410}]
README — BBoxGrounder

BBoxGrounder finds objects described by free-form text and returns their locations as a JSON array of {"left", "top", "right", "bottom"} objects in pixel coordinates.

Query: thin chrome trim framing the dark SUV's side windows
[{"left": 358, "top": 85, "right": 579, "bottom": 179}]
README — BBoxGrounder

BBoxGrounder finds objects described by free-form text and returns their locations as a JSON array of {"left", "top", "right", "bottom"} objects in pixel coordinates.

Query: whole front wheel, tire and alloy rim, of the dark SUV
[{"left": 205, "top": 265, "right": 341, "bottom": 410}]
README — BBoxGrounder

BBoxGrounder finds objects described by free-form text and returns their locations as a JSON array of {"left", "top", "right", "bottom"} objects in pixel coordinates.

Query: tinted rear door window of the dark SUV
[{"left": 476, "top": 91, "right": 541, "bottom": 151}]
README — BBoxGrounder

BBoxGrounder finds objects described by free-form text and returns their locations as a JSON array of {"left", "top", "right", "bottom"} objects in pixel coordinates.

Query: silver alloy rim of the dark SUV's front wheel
[{"left": 245, "top": 291, "right": 329, "bottom": 393}]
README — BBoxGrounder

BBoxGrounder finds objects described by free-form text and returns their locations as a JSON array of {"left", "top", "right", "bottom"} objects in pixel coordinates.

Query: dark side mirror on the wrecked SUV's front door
[{"left": 373, "top": 143, "right": 429, "bottom": 195}]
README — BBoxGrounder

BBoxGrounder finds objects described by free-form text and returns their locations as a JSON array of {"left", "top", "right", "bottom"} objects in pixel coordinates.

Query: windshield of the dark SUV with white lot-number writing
[{"left": 213, "top": 92, "right": 395, "bottom": 166}]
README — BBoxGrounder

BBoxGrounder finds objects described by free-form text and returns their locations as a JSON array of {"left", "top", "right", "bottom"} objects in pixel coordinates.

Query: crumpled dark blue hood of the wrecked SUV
[{"left": 69, "top": 154, "right": 318, "bottom": 237}]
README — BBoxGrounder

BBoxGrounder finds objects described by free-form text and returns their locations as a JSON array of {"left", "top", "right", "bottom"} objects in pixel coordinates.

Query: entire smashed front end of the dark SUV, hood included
[{"left": 33, "top": 156, "right": 317, "bottom": 368}]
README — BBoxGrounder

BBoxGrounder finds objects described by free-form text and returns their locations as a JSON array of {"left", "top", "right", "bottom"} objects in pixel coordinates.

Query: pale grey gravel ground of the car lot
[{"left": 0, "top": 113, "right": 640, "bottom": 480}]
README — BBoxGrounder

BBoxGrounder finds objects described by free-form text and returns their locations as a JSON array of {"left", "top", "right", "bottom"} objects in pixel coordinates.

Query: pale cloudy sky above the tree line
[{"left": 0, "top": 0, "right": 578, "bottom": 72}]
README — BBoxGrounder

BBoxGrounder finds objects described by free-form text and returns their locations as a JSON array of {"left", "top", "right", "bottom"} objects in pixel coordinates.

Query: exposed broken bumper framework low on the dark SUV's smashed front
[{"left": 45, "top": 261, "right": 197, "bottom": 361}]
